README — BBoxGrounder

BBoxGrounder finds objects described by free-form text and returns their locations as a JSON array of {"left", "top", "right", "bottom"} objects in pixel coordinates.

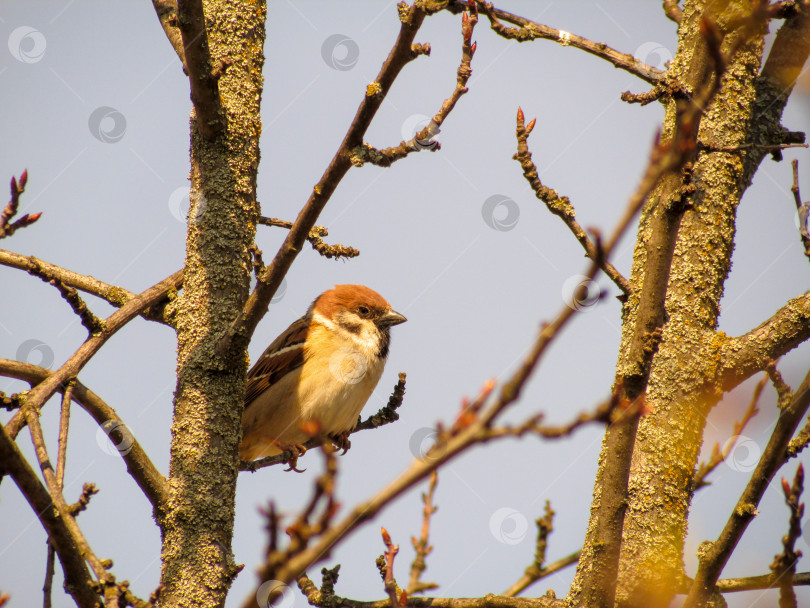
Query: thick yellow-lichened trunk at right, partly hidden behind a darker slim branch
[{"left": 569, "top": 2, "right": 804, "bottom": 607}]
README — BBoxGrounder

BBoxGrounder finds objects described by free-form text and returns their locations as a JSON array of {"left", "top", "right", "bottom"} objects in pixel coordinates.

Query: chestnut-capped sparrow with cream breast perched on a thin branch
[{"left": 239, "top": 285, "right": 407, "bottom": 460}]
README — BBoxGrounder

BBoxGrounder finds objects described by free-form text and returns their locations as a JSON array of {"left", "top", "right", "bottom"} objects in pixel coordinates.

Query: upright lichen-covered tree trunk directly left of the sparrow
[{"left": 160, "top": 0, "right": 266, "bottom": 608}]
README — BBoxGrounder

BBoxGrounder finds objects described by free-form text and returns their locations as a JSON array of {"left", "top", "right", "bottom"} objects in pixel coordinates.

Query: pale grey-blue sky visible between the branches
[{"left": 0, "top": 0, "right": 810, "bottom": 608}]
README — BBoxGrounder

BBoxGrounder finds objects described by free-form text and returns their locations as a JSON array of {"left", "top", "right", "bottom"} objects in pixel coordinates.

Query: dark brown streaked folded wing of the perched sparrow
[{"left": 245, "top": 317, "right": 310, "bottom": 406}]
